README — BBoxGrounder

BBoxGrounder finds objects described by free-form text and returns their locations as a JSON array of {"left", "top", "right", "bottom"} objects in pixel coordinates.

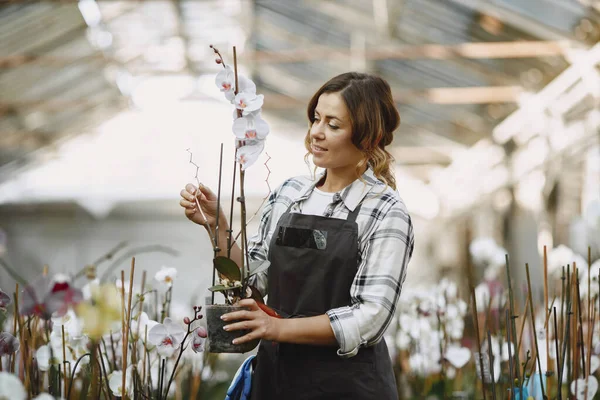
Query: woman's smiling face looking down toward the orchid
[{"left": 310, "top": 93, "right": 364, "bottom": 171}]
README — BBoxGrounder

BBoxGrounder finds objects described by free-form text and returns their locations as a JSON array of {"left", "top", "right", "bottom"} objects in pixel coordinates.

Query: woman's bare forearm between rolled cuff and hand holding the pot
[{"left": 275, "top": 314, "right": 337, "bottom": 346}]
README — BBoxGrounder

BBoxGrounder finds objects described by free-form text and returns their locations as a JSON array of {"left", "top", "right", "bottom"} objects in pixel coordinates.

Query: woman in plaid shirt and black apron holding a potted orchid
[{"left": 180, "top": 73, "right": 414, "bottom": 400}]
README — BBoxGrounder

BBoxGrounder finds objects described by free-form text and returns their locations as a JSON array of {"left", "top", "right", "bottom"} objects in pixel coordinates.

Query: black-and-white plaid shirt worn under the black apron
[{"left": 248, "top": 168, "right": 414, "bottom": 357}]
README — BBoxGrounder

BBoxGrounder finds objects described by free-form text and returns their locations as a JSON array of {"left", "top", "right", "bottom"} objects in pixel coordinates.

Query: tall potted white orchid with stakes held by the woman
[{"left": 198, "top": 45, "right": 274, "bottom": 353}]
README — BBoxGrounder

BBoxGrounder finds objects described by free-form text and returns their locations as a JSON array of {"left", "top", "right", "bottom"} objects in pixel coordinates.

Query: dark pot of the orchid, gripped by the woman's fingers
[{"left": 204, "top": 304, "right": 260, "bottom": 353}]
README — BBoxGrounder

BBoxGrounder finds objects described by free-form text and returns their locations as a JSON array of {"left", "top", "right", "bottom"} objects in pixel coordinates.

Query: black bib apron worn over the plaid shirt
[{"left": 251, "top": 198, "right": 398, "bottom": 400}]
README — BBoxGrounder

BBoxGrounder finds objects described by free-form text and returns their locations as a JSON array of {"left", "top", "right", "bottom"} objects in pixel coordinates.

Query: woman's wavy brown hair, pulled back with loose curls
[{"left": 304, "top": 72, "right": 400, "bottom": 190}]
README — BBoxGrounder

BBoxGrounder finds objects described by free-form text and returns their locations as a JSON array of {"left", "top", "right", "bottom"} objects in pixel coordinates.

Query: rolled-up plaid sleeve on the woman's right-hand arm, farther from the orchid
[{"left": 327, "top": 202, "right": 414, "bottom": 358}]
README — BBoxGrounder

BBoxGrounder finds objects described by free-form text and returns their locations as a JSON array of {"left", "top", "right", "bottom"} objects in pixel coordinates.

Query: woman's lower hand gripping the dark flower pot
[{"left": 221, "top": 299, "right": 281, "bottom": 344}]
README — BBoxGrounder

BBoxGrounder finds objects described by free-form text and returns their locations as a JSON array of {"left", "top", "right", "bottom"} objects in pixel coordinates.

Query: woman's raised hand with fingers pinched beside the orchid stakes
[{"left": 179, "top": 183, "right": 227, "bottom": 229}]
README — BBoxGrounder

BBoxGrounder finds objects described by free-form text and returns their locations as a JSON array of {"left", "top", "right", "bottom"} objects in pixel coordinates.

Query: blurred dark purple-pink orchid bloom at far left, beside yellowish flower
[{"left": 21, "top": 274, "right": 83, "bottom": 319}]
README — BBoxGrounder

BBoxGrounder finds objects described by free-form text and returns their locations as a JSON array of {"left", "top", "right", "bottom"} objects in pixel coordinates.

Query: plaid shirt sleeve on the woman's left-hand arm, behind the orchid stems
[{"left": 248, "top": 182, "right": 285, "bottom": 297}]
